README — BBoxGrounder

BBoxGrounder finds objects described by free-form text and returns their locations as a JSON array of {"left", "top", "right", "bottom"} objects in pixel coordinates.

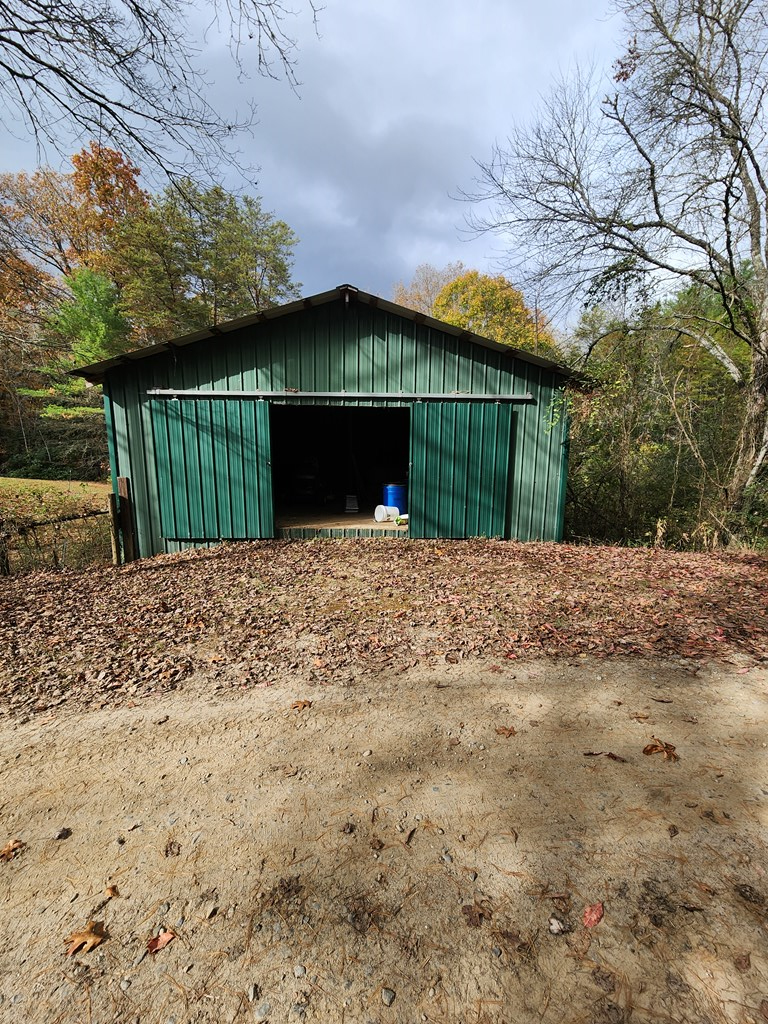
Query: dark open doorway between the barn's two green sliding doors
[{"left": 270, "top": 404, "right": 410, "bottom": 526}]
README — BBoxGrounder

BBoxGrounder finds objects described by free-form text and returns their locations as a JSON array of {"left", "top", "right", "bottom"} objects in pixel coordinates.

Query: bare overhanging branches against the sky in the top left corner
[{"left": 0, "top": 0, "right": 315, "bottom": 172}]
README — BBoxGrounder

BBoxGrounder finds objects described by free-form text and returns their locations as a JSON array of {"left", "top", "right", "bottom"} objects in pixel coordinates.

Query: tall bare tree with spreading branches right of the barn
[{"left": 473, "top": 0, "right": 768, "bottom": 507}]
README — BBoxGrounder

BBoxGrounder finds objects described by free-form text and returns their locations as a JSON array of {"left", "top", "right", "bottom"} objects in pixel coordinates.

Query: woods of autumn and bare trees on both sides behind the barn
[{"left": 0, "top": 0, "right": 768, "bottom": 548}]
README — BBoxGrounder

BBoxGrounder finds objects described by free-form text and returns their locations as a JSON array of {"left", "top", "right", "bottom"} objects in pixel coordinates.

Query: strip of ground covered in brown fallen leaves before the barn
[{"left": 0, "top": 541, "right": 768, "bottom": 715}]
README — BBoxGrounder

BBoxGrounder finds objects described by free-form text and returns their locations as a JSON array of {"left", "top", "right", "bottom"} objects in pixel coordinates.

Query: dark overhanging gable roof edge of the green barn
[{"left": 70, "top": 285, "right": 575, "bottom": 384}]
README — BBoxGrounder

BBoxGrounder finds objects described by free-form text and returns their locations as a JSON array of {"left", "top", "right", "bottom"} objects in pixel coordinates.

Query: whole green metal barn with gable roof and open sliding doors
[{"left": 76, "top": 285, "right": 568, "bottom": 556}]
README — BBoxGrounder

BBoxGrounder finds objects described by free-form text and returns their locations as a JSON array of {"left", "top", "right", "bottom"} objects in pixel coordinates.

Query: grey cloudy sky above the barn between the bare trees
[{"left": 0, "top": 0, "right": 622, "bottom": 315}]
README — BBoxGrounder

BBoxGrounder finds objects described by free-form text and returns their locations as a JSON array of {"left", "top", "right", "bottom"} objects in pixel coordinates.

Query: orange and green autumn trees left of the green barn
[{"left": 0, "top": 142, "right": 297, "bottom": 479}]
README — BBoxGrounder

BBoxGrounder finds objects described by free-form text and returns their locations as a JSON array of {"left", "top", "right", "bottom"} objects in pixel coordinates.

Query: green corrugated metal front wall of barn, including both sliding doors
[{"left": 104, "top": 300, "right": 566, "bottom": 555}]
